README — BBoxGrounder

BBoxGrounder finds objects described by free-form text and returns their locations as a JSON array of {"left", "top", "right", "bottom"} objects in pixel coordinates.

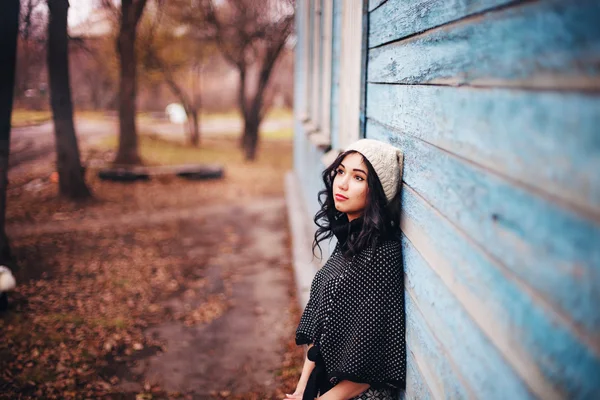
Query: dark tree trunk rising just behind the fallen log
[{"left": 114, "top": 0, "right": 141, "bottom": 165}]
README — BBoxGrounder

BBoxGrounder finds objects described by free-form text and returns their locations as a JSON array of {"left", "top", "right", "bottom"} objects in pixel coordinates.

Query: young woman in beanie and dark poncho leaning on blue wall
[{"left": 286, "top": 139, "right": 406, "bottom": 400}]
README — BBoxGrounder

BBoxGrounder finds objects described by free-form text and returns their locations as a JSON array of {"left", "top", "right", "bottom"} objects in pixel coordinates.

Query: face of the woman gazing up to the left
[{"left": 333, "top": 153, "right": 368, "bottom": 221}]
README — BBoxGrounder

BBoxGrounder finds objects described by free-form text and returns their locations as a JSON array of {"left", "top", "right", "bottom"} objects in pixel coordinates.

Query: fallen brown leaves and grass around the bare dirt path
[{"left": 0, "top": 136, "right": 303, "bottom": 400}]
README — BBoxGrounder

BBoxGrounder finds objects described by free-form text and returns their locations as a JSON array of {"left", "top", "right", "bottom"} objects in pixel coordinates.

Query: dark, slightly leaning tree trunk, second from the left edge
[{"left": 48, "top": 0, "right": 90, "bottom": 199}]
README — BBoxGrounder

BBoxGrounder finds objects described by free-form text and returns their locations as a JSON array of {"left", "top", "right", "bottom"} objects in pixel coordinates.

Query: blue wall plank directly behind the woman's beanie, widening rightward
[{"left": 368, "top": 120, "right": 600, "bottom": 344}]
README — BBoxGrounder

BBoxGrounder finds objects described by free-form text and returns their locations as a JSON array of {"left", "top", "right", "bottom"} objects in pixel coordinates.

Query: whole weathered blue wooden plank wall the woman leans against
[{"left": 366, "top": 0, "right": 600, "bottom": 399}]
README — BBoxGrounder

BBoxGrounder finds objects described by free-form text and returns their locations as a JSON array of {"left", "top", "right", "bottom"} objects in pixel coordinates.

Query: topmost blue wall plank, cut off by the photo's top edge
[{"left": 369, "top": 0, "right": 514, "bottom": 47}]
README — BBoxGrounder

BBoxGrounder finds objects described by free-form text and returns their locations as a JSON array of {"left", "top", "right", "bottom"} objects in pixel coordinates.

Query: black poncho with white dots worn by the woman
[{"left": 296, "top": 218, "right": 406, "bottom": 398}]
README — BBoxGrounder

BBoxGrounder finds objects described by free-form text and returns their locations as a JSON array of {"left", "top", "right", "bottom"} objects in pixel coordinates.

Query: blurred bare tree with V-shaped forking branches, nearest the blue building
[{"left": 196, "top": 0, "right": 294, "bottom": 160}]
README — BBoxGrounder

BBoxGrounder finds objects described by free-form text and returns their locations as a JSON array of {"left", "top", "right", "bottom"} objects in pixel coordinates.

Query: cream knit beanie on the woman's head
[{"left": 346, "top": 139, "right": 404, "bottom": 203}]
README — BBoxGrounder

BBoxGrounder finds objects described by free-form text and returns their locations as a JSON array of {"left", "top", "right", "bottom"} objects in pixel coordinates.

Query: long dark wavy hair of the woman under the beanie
[{"left": 312, "top": 150, "right": 400, "bottom": 258}]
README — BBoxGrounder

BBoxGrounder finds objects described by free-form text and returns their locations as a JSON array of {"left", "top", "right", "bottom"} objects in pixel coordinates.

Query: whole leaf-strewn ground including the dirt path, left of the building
[{"left": 0, "top": 138, "right": 303, "bottom": 399}]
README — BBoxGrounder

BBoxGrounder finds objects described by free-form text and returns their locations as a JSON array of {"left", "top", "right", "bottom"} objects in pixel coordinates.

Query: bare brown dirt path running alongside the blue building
[{"left": 114, "top": 203, "right": 291, "bottom": 398}]
